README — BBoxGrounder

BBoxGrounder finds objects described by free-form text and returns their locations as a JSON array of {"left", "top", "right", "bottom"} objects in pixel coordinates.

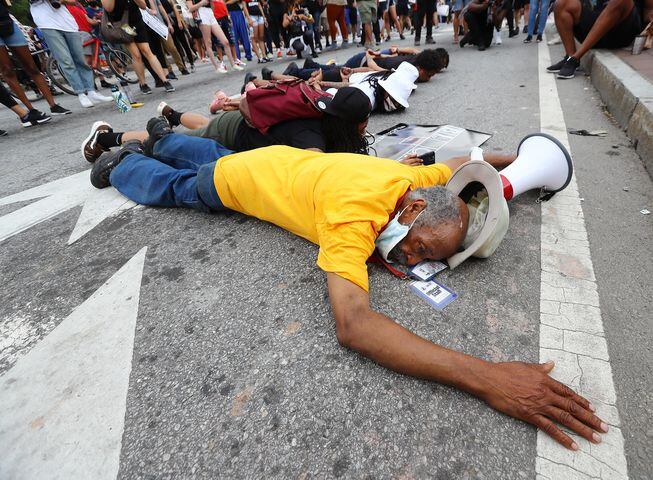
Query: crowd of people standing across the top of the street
[{"left": 0, "top": 0, "right": 650, "bottom": 134}]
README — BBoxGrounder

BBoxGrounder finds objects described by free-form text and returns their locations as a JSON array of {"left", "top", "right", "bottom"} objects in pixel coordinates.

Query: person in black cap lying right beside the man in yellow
[{"left": 81, "top": 87, "right": 372, "bottom": 163}]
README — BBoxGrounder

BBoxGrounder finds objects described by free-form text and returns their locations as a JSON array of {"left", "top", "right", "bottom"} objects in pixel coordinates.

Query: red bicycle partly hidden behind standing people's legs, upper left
[{"left": 45, "top": 36, "right": 138, "bottom": 95}]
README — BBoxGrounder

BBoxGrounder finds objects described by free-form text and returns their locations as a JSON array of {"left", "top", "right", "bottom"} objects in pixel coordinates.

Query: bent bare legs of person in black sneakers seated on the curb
[{"left": 554, "top": 0, "right": 634, "bottom": 60}]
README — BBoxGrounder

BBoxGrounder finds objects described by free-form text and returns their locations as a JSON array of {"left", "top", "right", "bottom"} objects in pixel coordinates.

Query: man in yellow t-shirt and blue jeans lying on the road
[{"left": 91, "top": 119, "right": 607, "bottom": 450}]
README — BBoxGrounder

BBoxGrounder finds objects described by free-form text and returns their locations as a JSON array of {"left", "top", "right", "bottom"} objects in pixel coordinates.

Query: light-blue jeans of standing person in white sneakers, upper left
[{"left": 41, "top": 28, "right": 95, "bottom": 94}]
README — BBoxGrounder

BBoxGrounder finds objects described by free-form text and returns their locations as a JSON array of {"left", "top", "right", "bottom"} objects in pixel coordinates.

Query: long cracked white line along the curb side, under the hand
[{"left": 535, "top": 34, "right": 628, "bottom": 480}]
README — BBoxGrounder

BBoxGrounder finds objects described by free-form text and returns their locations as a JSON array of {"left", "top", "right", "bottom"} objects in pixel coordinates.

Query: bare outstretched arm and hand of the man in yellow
[{"left": 327, "top": 273, "right": 608, "bottom": 450}]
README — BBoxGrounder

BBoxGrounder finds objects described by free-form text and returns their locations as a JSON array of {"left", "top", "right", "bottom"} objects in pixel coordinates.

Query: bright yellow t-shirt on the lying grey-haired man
[{"left": 213, "top": 146, "right": 451, "bottom": 291}]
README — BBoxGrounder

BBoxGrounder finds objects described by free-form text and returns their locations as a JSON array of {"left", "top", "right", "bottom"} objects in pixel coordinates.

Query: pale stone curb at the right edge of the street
[{"left": 581, "top": 50, "right": 653, "bottom": 178}]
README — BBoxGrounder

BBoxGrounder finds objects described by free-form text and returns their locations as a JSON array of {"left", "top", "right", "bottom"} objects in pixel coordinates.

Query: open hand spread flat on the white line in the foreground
[{"left": 481, "top": 362, "right": 608, "bottom": 450}]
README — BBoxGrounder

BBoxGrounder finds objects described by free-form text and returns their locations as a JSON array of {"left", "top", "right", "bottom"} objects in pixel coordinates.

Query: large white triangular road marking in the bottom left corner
[{"left": 0, "top": 247, "right": 147, "bottom": 480}]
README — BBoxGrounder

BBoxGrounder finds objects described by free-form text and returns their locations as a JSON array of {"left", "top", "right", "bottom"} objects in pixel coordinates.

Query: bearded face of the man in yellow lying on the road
[{"left": 388, "top": 199, "right": 469, "bottom": 266}]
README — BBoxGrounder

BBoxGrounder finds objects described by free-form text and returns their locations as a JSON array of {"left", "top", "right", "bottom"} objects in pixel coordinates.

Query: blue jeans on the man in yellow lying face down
[{"left": 109, "top": 133, "right": 234, "bottom": 212}]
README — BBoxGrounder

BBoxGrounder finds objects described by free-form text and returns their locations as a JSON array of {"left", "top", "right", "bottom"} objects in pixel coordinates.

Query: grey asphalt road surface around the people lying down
[{"left": 0, "top": 24, "right": 653, "bottom": 479}]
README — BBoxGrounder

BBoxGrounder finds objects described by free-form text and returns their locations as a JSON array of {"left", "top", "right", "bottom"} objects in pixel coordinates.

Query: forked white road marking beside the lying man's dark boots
[{"left": 0, "top": 170, "right": 136, "bottom": 245}]
